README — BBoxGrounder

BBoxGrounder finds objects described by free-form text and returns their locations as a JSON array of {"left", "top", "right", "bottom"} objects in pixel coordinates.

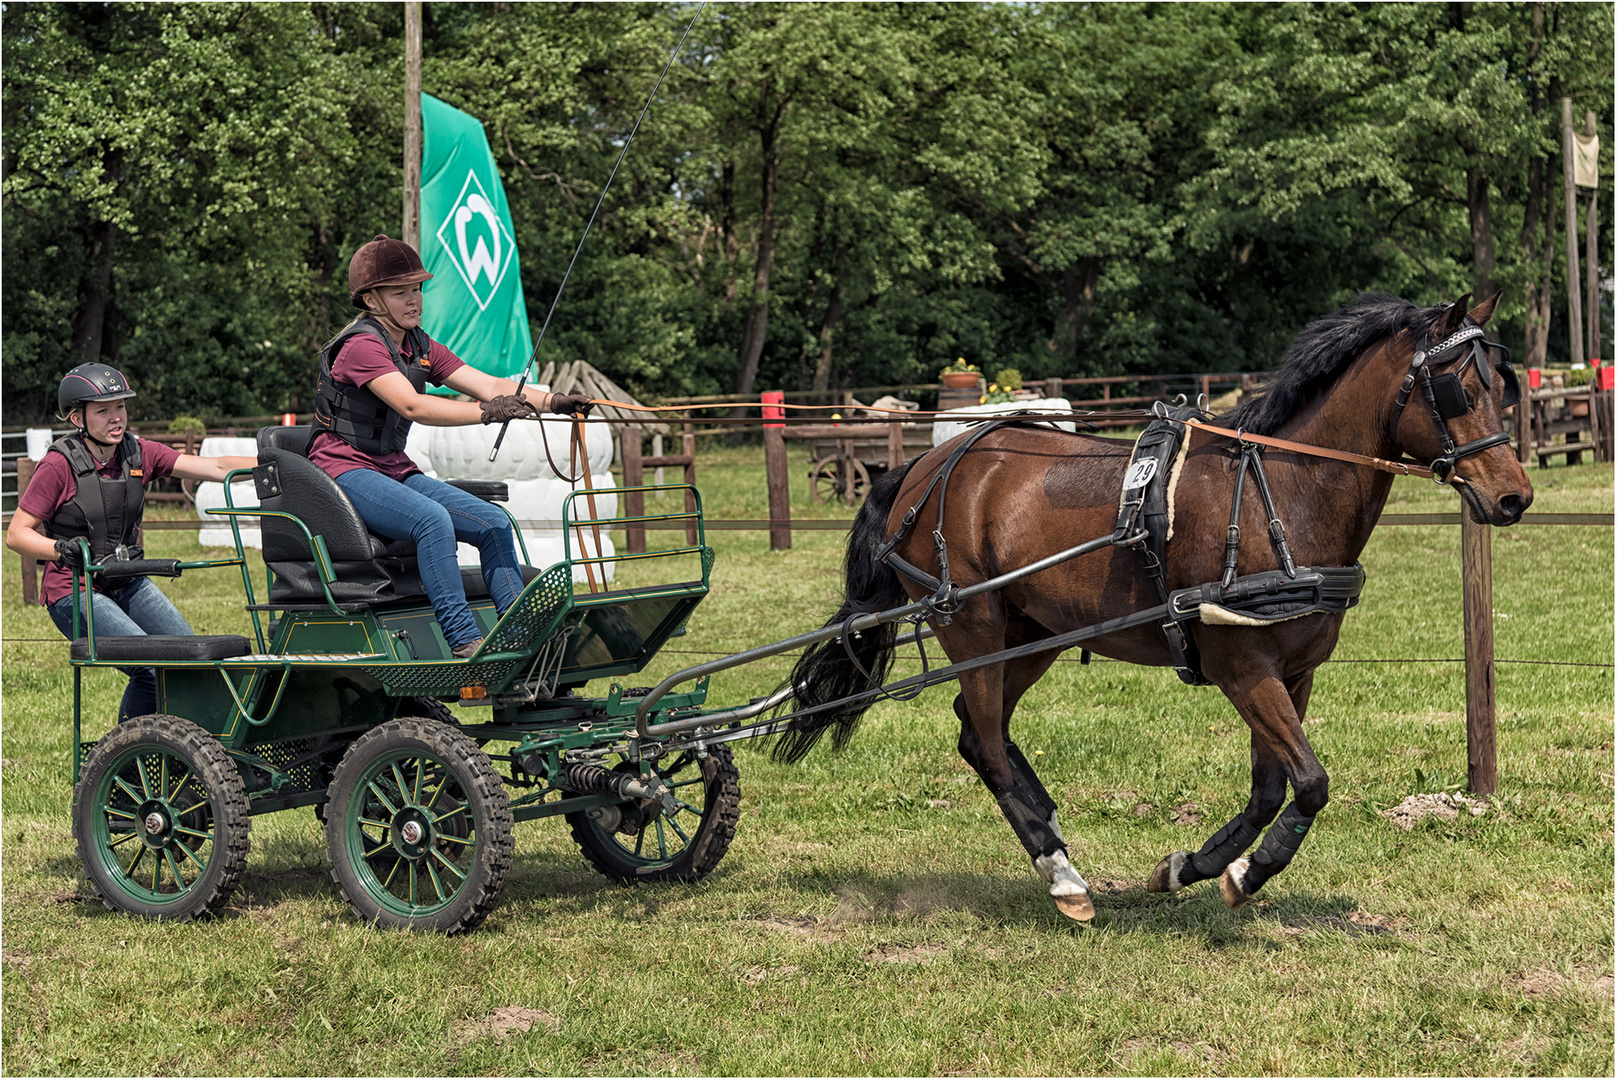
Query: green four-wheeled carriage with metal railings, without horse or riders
[{"left": 71, "top": 433, "right": 739, "bottom": 933}]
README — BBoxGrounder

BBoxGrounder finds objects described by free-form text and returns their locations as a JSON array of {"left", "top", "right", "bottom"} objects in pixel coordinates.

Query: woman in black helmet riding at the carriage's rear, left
[{"left": 5, "top": 364, "right": 257, "bottom": 724}]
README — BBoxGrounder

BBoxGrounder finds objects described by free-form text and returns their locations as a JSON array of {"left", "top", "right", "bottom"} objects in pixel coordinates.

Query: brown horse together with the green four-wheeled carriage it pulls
[{"left": 63, "top": 297, "right": 1531, "bottom": 933}]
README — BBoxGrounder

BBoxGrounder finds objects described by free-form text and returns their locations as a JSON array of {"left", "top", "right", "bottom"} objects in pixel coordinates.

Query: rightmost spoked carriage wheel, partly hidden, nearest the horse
[{"left": 568, "top": 745, "right": 741, "bottom": 881}]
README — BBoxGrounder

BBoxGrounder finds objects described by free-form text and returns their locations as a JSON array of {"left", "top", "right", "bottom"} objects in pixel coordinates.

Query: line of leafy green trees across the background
[{"left": 0, "top": 3, "right": 1614, "bottom": 424}]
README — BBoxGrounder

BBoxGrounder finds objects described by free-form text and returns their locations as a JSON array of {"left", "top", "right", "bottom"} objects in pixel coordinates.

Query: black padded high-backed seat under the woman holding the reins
[{"left": 252, "top": 424, "right": 538, "bottom": 606}]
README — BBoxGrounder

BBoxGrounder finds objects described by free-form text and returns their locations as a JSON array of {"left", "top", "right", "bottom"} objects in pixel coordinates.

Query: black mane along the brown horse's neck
[{"left": 1219, "top": 293, "right": 1444, "bottom": 435}]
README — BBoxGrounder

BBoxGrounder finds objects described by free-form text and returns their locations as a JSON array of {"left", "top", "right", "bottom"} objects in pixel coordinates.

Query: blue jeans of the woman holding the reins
[{"left": 336, "top": 469, "right": 522, "bottom": 648}]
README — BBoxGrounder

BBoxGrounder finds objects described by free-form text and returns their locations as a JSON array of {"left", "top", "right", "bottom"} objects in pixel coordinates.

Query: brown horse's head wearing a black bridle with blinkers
[{"left": 1394, "top": 293, "right": 1533, "bottom": 525}]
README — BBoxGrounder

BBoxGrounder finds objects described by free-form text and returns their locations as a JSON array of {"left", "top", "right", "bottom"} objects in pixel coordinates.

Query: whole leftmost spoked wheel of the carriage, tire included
[{"left": 73, "top": 716, "right": 249, "bottom": 922}]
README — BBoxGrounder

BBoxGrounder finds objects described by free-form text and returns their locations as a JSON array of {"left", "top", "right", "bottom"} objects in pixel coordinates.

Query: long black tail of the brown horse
[{"left": 773, "top": 461, "right": 914, "bottom": 761}]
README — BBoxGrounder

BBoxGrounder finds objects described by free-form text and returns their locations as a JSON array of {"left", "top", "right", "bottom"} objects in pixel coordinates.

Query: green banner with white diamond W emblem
[{"left": 420, "top": 94, "right": 534, "bottom": 393}]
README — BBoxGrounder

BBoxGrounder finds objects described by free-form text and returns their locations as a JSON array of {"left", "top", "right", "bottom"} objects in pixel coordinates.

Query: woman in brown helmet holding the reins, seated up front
[{"left": 309, "top": 236, "right": 590, "bottom": 660}]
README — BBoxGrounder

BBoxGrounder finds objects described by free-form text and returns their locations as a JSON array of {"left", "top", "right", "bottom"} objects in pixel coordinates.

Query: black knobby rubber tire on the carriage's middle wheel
[{"left": 325, "top": 716, "right": 516, "bottom": 934}]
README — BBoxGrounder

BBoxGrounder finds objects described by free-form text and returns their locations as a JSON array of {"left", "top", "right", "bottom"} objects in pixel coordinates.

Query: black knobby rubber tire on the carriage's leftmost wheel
[{"left": 73, "top": 715, "right": 251, "bottom": 923}]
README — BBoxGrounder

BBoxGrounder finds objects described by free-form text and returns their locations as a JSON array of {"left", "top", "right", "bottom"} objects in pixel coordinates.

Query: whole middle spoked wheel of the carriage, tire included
[{"left": 325, "top": 716, "right": 514, "bottom": 934}]
